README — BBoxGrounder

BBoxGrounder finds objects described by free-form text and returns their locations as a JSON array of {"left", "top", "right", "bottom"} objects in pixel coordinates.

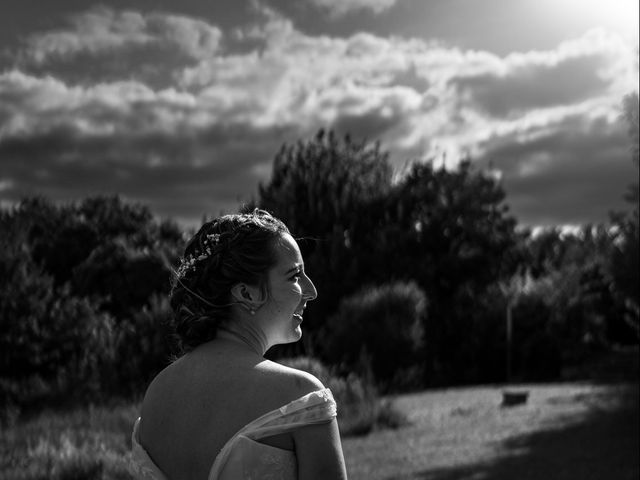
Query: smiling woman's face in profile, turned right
[{"left": 261, "top": 233, "right": 317, "bottom": 344}]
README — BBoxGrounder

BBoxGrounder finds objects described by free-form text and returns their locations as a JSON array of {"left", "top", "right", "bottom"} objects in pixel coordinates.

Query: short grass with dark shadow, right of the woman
[{"left": 343, "top": 383, "right": 640, "bottom": 480}]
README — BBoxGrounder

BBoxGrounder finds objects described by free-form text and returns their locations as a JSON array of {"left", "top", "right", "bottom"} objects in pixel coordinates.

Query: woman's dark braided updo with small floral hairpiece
[{"left": 170, "top": 209, "right": 289, "bottom": 353}]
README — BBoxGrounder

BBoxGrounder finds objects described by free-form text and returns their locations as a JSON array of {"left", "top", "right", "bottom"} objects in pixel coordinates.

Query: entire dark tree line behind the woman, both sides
[{"left": 0, "top": 96, "right": 640, "bottom": 412}]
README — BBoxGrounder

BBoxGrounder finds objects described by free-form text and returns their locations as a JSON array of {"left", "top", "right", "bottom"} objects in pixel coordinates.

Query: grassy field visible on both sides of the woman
[{"left": 0, "top": 383, "right": 640, "bottom": 480}]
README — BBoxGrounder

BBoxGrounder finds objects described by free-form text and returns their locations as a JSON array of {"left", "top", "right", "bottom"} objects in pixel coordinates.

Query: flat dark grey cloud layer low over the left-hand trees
[{"left": 0, "top": 106, "right": 288, "bottom": 224}]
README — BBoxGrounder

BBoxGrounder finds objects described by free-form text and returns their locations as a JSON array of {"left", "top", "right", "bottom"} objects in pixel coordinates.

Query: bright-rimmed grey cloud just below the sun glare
[{"left": 452, "top": 31, "right": 637, "bottom": 117}]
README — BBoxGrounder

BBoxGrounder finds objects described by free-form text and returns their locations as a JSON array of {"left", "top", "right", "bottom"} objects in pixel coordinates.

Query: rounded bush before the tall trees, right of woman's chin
[{"left": 323, "top": 282, "right": 427, "bottom": 390}]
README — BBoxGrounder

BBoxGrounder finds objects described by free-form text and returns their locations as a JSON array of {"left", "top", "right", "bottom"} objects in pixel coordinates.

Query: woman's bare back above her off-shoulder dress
[{"left": 139, "top": 341, "right": 323, "bottom": 479}]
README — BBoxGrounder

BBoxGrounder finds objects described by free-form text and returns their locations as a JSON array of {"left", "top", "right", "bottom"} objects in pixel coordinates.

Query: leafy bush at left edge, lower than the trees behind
[{"left": 0, "top": 242, "right": 114, "bottom": 407}]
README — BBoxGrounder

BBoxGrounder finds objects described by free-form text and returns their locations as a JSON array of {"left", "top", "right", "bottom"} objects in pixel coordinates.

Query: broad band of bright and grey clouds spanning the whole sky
[{"left": 0, "top": 4, "right": 637, "bottom": 223}]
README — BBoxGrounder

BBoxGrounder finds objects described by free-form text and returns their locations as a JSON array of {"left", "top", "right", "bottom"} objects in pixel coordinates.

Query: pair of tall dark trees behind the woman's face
[{"left": 258, "top": 131, "right": 520, "bottom": 382}]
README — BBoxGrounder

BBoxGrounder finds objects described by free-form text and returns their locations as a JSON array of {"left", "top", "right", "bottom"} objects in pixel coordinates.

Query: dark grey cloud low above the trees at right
[{"left": 477, "top": 115, "right": 637, "bottom": 225}]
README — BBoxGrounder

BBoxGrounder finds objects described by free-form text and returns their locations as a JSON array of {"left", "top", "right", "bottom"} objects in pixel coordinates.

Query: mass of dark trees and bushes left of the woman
[{"left": 0, "top": 197, "right": 182, "bottom": 408}]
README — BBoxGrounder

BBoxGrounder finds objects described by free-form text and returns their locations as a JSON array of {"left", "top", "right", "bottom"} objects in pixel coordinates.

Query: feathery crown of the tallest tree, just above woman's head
[{"left": 259, "top": 130, "right": 391, "bottom": 236}]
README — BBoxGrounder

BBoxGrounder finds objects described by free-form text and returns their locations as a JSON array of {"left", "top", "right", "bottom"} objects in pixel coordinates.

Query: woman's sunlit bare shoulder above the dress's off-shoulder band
[{"left": 258, "top": 360, "right": 325, "bottom": 404}]
